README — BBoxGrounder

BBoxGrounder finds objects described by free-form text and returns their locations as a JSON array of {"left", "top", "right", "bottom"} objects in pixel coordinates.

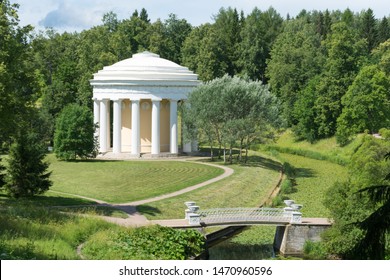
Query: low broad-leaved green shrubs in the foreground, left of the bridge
[{"left": 83, "top": 226, "right": 205, "bottom": 260}]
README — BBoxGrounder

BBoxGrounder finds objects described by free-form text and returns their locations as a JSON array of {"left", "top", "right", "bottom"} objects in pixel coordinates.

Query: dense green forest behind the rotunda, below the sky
[{"left": 0, "top": 1, "right": 390, "bottom": 150}]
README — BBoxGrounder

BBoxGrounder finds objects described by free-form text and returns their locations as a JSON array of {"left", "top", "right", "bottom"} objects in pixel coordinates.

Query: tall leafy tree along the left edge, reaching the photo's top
[{"left": 0, "top": 0, "right": 40, "bottom": 143}]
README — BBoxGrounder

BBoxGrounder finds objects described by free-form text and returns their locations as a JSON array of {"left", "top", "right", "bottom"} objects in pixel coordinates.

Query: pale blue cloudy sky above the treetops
[{"left": 10, "top": 0, "right": 390, "bottom": 32}]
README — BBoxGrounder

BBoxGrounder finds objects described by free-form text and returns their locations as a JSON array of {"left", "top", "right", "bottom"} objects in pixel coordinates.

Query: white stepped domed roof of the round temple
[{"left": 91, "top": 51, "right": 198, "bottom": 85}]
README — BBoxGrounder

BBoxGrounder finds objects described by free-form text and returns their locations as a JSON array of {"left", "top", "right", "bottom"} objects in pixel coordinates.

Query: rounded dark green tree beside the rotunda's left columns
[{"left": 54, "top": 104, "right": 97, "bottom": 160}]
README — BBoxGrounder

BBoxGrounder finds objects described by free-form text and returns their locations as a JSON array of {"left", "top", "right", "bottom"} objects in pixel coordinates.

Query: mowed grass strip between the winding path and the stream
[{"left": 137, "top": 152, "right": 281, "bottom": 219}]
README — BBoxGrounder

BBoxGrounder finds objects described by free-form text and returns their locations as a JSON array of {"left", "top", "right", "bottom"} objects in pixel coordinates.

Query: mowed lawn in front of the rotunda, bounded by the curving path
[{"left": 48, "top": 155, "right": 224, "bottom": 203}]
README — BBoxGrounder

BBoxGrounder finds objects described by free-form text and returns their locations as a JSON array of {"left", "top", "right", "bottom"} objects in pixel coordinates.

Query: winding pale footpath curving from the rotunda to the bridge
[{"left": 50, "top": 160, "right": 234, "bottom": 227}]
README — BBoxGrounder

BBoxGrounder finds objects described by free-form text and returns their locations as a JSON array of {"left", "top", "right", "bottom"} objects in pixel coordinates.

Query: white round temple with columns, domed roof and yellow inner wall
[{"left": 90, "top": 52, "right": 199, "bottom": 157}]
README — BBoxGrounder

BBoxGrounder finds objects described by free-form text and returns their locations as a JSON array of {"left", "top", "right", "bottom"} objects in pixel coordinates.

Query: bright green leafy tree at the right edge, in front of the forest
[{"left": 336, "top": 65, "right": 390, "bottom": 144}]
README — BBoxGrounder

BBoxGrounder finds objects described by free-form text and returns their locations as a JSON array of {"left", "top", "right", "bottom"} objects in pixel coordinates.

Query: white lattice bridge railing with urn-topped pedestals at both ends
[{"left": 185, "top": 202, "right": 302, "bottom": 225}]
